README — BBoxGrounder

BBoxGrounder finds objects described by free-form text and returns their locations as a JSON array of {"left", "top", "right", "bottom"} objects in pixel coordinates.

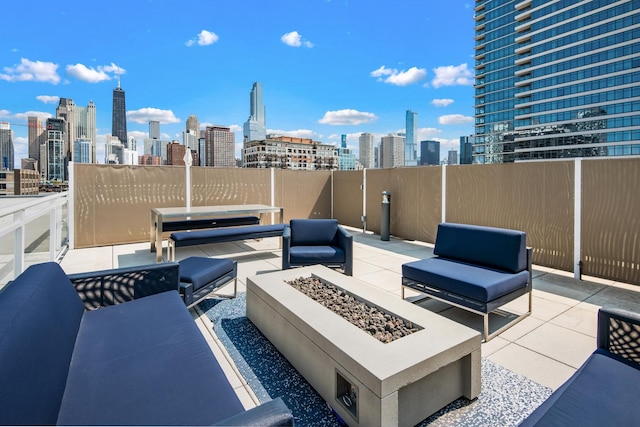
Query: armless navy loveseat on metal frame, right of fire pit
[{"left": 402, "top": 223, "right": 533, "bottom": 342}]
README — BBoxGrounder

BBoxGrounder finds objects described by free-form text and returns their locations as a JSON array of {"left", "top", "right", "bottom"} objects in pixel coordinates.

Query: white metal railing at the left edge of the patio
[{"left": 0, "top": 192, "right": 69, "bottom": 288}]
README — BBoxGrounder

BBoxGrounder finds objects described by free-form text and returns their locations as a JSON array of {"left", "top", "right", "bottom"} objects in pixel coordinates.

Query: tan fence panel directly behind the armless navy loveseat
[{"left": 446, "top": 162, "right": 573, "bottom": 271}]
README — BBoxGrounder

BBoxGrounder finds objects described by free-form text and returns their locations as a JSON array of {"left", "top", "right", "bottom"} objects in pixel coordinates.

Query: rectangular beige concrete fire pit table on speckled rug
[{"left": 247, "top": 266, "right": 481, "bottom": 426}]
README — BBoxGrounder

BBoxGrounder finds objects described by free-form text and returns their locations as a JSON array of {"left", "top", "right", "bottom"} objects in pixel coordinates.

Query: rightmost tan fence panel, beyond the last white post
[{"left": 581, "top": 158, "right": 640, "bottom": 284}]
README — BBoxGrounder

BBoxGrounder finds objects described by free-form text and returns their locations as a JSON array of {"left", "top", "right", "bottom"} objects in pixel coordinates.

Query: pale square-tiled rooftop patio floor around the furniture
[{"left": 61, "top": 228, "right": 640, "bottom": 424}]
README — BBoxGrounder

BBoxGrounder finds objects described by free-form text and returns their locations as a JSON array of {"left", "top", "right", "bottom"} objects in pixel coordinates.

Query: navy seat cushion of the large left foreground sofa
[{"left": 58, "top": 291, "right": 244, "bottom": 425}]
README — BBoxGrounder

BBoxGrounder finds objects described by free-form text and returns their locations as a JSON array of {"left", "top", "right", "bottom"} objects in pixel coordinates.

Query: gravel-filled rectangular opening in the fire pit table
[{"left": 285, "top": 276, "right": 423, "bottom": 343}]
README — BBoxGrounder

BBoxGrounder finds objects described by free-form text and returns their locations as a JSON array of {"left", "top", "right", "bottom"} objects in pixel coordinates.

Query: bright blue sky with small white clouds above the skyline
[{"left": 0, "top": 0, "right": 474, "bottom": 167}]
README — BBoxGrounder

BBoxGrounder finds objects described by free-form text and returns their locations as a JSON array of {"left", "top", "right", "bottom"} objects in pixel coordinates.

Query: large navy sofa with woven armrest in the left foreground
[{"left": 0, "top": 263, "right": 293, "bottom": 425}]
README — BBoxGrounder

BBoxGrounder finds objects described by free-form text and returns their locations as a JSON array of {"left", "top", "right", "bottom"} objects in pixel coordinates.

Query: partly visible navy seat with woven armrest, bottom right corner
[{"left": 520, "top": 308, "right": 640, "bottom": 427}]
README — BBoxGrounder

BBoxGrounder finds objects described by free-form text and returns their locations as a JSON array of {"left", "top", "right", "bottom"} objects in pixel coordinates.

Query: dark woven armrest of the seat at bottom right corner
[{"left": 598, "top": 308, "right": 640, "bottom": 369}]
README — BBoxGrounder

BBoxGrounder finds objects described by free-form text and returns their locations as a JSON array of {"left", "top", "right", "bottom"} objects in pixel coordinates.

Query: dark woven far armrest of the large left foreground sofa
[{"left": 67, "top": 262, "right": 180, "bottom": 310}]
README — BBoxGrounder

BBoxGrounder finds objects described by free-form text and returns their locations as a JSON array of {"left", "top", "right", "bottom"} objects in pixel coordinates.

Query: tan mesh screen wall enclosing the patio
[{"left": 72, "top": 158, "right": 640, "bottom": 284}]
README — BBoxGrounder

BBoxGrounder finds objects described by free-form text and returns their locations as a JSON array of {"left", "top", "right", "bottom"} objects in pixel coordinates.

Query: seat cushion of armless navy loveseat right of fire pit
[{"left": 402, "top": 257, "right": 529, "bottom": 303}]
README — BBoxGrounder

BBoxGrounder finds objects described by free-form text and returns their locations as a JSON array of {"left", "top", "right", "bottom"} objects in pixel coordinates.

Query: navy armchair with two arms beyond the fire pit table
[{"left": 282, "top": 219, "right": 353, "bottom": 276}]
